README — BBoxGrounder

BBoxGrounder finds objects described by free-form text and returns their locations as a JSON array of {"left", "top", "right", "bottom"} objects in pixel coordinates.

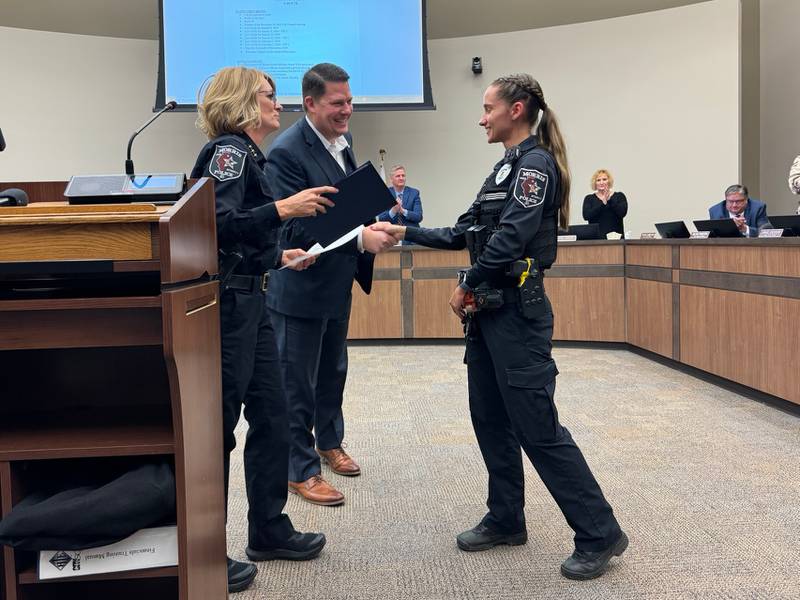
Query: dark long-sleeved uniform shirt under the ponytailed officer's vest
[{"left": 406, "top": 136, "right": 560, "bottom": 288}]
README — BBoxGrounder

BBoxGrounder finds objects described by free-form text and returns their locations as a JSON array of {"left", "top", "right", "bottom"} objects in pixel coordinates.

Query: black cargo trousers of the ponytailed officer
[{"left": 465, "top": 300, "right": 620, "bottom": 551}]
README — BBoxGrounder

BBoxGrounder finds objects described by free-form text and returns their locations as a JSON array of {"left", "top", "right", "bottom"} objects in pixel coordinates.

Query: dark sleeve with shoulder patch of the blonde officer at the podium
[{"left": 203, "top": 144, "right": 281, "bottom": 248}]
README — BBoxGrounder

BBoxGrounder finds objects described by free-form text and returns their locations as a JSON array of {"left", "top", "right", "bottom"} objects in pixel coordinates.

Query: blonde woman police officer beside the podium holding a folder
[{"left": 192, "top": 67, "right": 336, "bottom": 592}]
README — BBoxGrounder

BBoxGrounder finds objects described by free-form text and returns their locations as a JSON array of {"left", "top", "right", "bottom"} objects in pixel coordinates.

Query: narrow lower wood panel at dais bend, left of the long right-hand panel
[{"left": 625, "top": 279, "right": 672, "bottom": 358}]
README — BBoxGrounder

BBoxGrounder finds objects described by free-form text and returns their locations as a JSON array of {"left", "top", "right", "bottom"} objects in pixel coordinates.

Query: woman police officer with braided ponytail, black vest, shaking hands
[{"left": 372, "top": 74, "right": 628, "bottom": 579}]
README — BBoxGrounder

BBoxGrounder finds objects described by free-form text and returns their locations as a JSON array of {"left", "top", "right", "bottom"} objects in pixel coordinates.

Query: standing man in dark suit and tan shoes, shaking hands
[{"left": 266, "top": 63, "right": 396, "bottom": 506}]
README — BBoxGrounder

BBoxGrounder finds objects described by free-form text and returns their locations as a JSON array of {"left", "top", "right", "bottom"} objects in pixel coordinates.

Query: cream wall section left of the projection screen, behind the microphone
[{"left": 0, "top": 27, "right": 204, "bottom": 181}]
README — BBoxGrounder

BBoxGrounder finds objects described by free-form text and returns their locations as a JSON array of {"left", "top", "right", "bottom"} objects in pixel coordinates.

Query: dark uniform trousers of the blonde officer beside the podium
[{"left": 220, "top": 289, "right": 294, "bottom": 550}]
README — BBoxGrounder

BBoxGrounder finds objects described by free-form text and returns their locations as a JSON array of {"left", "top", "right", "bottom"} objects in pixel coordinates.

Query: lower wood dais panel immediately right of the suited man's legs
[{"left": 347, "top": 279, "right": 403, "bottom": 340}]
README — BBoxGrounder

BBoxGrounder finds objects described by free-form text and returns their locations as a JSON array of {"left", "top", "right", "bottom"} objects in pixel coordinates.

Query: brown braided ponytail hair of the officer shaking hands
[{"left": 492, "top": 73, "right": 572, "bottom": 229}]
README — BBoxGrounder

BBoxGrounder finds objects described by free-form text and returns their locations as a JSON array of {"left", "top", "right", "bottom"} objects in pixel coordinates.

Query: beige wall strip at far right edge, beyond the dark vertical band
[{"left": 760, "top": 0, "right": 800, "bottom": 215}]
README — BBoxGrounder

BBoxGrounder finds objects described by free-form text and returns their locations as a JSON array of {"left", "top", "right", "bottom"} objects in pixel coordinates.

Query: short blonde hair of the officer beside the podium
[{"left": 196, "top": 67, "right": 275, "bottom": 139}]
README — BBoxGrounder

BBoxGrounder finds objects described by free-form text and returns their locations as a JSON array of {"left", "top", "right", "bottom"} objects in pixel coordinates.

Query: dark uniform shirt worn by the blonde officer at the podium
[{"left": 191, "top": 133, "right": 281, "bottom": 275}]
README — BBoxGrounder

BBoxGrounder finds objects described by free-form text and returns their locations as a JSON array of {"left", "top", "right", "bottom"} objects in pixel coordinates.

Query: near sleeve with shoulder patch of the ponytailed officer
[{"left": 464, "top": 152, "right": 557, "bottom": 288}]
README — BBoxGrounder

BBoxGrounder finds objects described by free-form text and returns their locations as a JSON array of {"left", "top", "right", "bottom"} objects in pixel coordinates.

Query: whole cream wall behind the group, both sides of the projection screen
[{"left": 0, "top": 0, "right": 739, "bottom": 232}]
